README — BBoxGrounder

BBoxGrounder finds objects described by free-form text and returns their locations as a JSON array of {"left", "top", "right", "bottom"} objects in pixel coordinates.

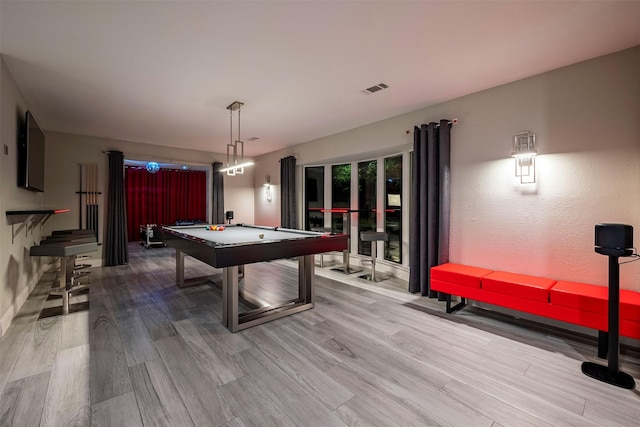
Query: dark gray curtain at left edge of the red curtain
[{"left": 104, "top": 151, "right": 129, "bottom": 266}]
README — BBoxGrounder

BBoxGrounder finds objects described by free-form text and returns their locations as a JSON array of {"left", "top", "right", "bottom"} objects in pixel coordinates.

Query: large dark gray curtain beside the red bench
[{"left": 409, "top": 120, "right": 451, "bottom": 299}]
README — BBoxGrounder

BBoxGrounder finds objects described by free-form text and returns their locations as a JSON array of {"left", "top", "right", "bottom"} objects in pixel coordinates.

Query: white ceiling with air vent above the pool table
[{"left": 0, "top": 0, "right": 640, "bottom": 156}]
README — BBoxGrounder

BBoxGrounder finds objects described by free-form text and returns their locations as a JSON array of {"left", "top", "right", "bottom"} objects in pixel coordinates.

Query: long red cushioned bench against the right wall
[{"left": 431, "top": 263, "right": 640, "bottom": 358}]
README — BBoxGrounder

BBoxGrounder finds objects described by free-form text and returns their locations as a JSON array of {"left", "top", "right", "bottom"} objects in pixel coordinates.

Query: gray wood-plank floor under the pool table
[{"left": 0, "top": 245, "right": 640, "bottom": 427}]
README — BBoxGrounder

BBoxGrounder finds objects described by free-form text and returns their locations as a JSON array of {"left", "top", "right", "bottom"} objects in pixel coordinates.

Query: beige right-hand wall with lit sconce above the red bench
[{"left": 255, "top": 47, "right": 640, "bottom": 291}]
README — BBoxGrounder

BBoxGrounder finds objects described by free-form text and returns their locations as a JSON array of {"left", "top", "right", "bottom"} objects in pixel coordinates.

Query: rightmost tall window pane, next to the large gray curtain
[{"left": 384, "top": 155, "right": 403, "bottom": 263}]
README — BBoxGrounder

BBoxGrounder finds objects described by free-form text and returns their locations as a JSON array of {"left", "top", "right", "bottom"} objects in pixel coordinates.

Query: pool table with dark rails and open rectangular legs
[{"left": 158, "top": 224, "right": 348, "bottom": 332}]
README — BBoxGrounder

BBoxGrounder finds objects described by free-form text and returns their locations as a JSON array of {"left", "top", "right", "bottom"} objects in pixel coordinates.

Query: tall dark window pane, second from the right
[{"left": 357, "top": 160, "right": 378, "bottom": 256}]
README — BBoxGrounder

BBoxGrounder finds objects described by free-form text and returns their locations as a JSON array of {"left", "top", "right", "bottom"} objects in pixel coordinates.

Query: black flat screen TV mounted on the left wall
[{"left": 18, "top": 111, "right": 44, "bottom": 191}]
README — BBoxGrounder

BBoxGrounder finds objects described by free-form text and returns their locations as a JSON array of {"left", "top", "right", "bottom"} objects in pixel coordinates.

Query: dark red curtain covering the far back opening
[{"left": 124, "top": 166, "right": 207, "bottom": 242}]
